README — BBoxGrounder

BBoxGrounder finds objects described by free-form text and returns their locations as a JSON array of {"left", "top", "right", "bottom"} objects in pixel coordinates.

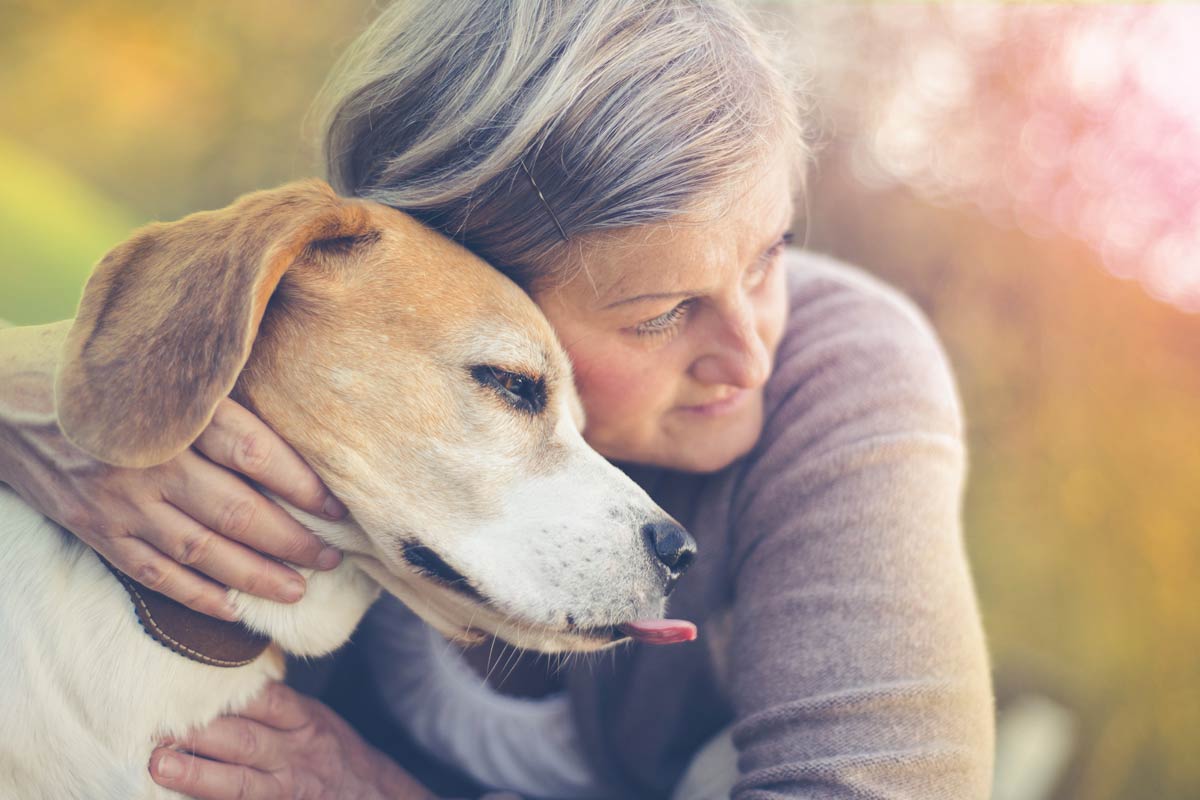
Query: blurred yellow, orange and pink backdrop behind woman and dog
[{"left": 0, "top": 0, "right": 1200, "bottom": 800}]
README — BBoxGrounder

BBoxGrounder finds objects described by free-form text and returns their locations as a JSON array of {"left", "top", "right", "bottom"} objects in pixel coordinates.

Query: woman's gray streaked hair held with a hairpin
[{"left": 317, "top": 0, "right": 808, "bottom": 288}]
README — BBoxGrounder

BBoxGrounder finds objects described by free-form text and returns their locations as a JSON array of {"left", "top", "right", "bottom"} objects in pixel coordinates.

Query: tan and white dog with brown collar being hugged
[{"left": 0, "top": 180, "right": 695, "bottom": 800}]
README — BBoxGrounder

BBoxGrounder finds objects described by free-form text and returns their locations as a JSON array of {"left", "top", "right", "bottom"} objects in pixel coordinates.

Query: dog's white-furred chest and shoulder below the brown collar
[{"left": 0, "top": 487, "right": 277, "bottom": 799}]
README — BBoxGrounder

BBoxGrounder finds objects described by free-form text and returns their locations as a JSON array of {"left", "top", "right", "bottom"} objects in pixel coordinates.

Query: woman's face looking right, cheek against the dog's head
[{"left": 533, "top": 154, "right": 793, "bottom": 471}]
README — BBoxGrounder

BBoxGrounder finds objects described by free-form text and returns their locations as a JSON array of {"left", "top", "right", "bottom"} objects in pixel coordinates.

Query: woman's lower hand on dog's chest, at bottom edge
[{"left": 150, "top": 684, "right": 434, "bottom": 800}]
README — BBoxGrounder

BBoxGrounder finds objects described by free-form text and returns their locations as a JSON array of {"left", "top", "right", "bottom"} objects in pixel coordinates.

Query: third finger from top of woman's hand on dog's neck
[{"left": 142, "top": 503, "right": 305, "bottom": 606}]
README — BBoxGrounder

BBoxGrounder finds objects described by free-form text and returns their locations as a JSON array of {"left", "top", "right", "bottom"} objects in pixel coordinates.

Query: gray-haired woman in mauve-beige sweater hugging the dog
[{"left": 0, "top": 0, "right": 992, "bottom": 800}]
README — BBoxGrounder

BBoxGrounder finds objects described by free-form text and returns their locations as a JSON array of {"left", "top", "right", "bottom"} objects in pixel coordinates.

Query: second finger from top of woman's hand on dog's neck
[{"left": 163, "top": 451, "right": 341, "bottom": 575}]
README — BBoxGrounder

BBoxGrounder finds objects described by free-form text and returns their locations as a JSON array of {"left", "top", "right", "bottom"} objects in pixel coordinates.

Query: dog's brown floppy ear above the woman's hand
[{"left": 55, "top": 180, "right": 371, "bottom": 467}]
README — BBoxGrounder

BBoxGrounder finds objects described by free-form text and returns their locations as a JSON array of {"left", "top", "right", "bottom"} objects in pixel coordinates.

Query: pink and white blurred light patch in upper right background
[{"left": 775, "top": 4, "right": 1200, "bottom": 312}]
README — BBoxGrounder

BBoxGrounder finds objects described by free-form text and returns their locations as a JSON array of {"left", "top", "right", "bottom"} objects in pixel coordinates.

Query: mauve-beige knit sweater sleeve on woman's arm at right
[{"left": 731, "top": 257, "right": 994, "bottom": 800}]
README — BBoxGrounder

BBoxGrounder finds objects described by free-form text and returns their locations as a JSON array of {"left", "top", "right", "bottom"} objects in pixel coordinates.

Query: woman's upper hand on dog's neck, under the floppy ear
[{"left": 0, "top": 323, "right": 346, "bottom": 619}]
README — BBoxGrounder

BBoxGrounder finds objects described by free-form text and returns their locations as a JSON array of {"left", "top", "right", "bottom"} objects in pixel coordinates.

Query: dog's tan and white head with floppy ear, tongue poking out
[{"left": 56, "top": 181, "right": 694, "bottom": 651}]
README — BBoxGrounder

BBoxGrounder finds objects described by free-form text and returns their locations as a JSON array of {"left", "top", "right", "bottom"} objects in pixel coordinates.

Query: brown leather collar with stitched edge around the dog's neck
[{"left": 97, "top": 554, "right": 271, "bottom": 667}]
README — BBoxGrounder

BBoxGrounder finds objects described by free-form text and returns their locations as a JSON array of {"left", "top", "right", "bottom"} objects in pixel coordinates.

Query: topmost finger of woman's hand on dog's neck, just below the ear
[{"left": 194, "top": 398, "right": 346, "bottom": 519}]
